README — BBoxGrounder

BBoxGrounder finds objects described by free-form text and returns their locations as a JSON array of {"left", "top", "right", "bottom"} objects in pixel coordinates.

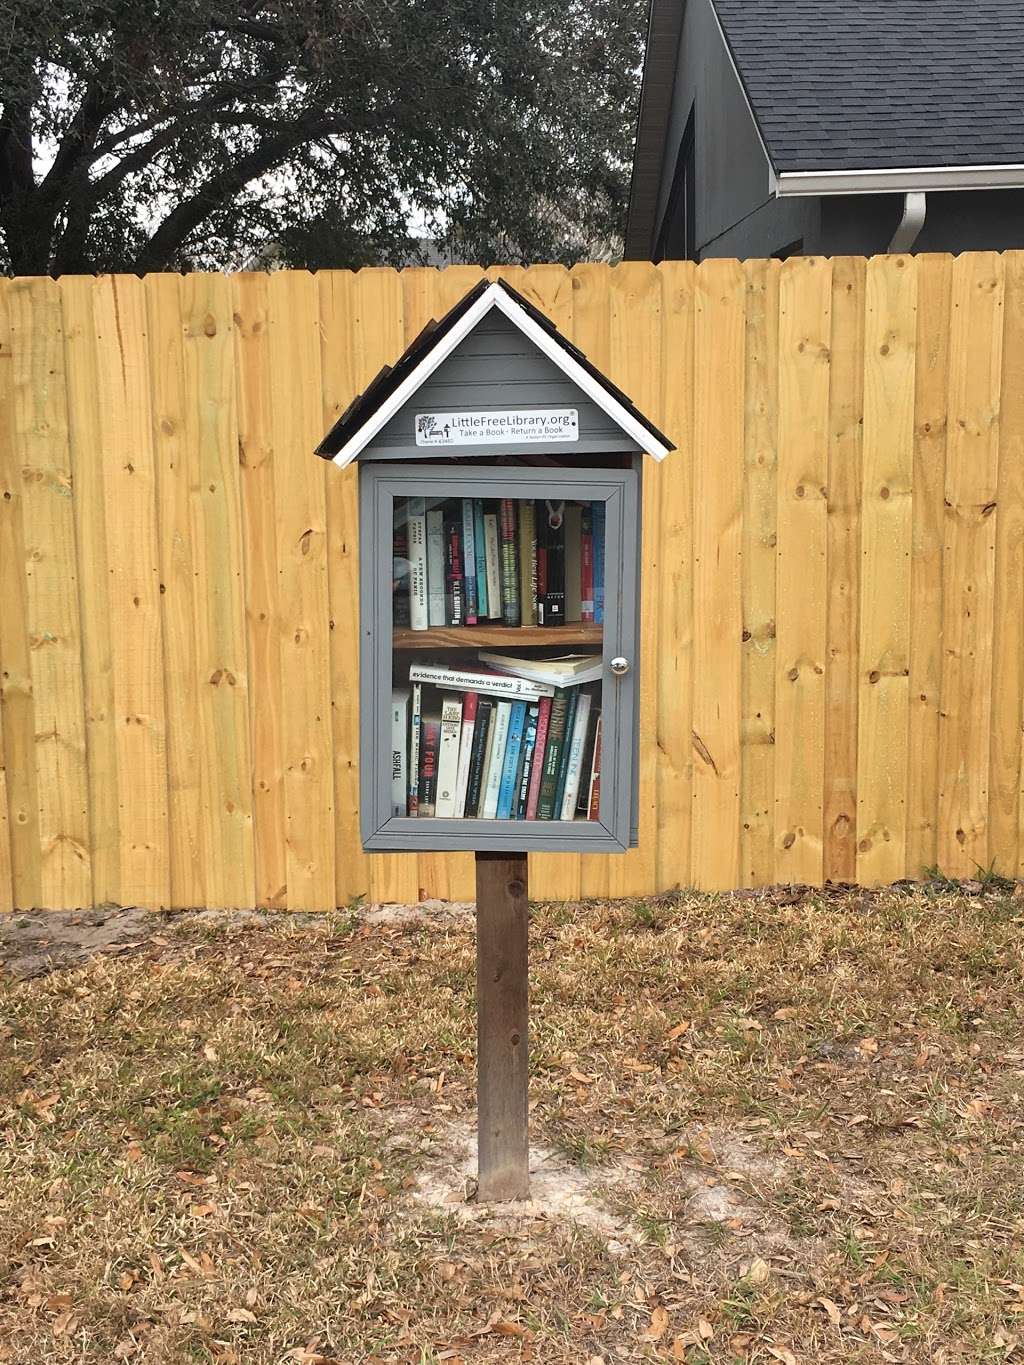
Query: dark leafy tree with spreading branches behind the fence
[{"left": 0, "top": 0, "right": 646, "bottom": 274}]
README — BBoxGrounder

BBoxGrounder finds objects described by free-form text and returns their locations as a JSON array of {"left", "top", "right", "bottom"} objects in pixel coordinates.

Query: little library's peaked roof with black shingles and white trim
[{"left": 315, "top": 280, "right": 676, "bottom": 465}]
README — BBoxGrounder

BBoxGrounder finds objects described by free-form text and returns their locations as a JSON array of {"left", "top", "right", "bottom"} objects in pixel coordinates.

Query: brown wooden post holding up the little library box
[{"left": 477, "top": 853, "right": 530, "bottom": 1203}]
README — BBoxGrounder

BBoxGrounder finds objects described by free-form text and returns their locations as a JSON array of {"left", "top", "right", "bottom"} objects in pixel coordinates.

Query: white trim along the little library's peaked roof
[{"left": 333, "top": 284, "right": 669, "bottom": 468}]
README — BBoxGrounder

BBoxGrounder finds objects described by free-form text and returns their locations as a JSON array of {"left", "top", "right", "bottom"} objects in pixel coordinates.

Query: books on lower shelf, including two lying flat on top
[{"left": 392, "top": 655, "right": 601, "bottom": 820}]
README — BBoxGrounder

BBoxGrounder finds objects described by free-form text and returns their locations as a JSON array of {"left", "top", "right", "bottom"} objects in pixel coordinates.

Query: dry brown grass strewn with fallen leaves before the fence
[{"left": 0, "top": 883, "right": 1024, "bottom": 1365}]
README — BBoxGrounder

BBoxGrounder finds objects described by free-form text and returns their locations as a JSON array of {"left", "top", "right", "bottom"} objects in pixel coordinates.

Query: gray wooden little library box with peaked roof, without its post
[{"left": 317, "top": 281, "right": 673, "bottom": 853}]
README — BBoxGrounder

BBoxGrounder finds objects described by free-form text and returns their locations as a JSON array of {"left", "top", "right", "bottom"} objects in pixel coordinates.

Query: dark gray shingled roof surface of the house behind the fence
[{"left": 713, "top": 0, "right": 1024, "bottom": 172}]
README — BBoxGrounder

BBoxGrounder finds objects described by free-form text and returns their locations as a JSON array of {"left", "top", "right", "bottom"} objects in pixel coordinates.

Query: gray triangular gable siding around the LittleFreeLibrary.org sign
[{"left": 367, "top": 308, "right": 639, "bottom": 460}]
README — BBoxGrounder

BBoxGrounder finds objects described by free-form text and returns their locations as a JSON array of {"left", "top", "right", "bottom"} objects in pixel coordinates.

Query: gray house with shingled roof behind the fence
[{"left": 625, "top": 0, "right": 1024, "bottom": 261}]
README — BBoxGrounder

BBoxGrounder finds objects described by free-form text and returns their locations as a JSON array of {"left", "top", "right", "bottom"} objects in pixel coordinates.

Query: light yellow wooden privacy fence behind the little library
[{"left": 0, "top": 254, "right": 1024, "bottom": 909}]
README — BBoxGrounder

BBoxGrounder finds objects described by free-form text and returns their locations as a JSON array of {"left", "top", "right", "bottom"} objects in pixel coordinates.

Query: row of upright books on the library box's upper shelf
[{"left": 393, "top": 498, "right": 605, "bottom": 631}]
